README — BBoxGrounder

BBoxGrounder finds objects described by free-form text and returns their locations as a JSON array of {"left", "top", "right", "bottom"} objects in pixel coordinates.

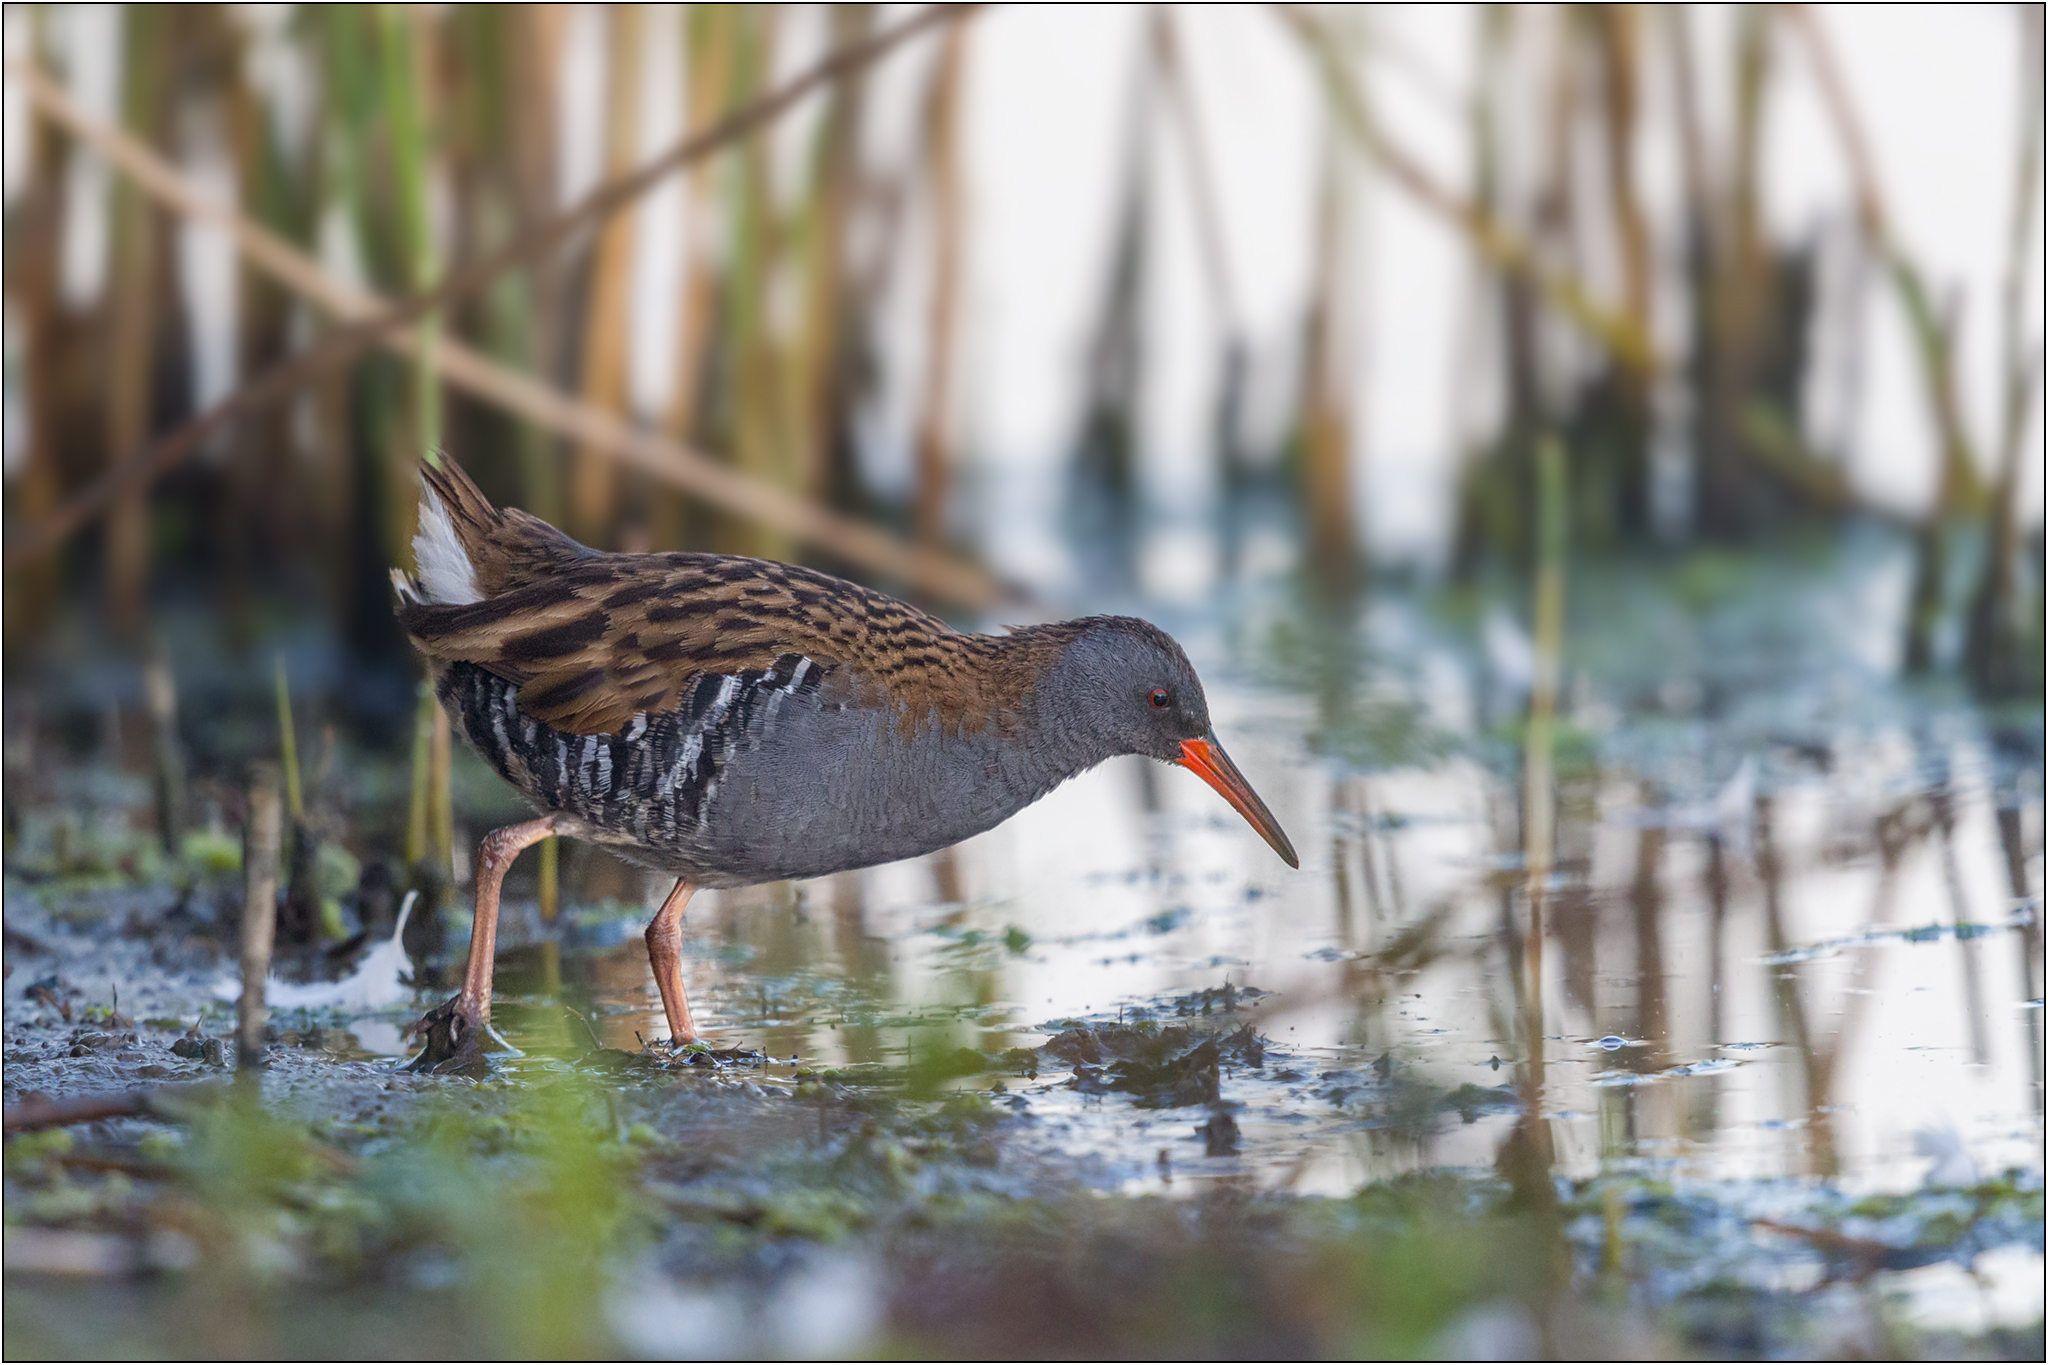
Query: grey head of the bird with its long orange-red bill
[{"left": 1038, "top": 616, "right": 1300, "bottom": 868}]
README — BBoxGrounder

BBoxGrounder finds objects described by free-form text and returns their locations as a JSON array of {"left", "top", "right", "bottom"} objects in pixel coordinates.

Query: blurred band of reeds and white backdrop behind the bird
[{"left": 6, "top": 4, "right": 2040, "bottom": 663}]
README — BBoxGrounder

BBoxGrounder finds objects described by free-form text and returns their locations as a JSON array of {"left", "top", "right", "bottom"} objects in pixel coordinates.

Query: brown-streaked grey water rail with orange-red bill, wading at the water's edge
[{"left": 391, "top": 456, "right": 1300, "bottom": 1068}]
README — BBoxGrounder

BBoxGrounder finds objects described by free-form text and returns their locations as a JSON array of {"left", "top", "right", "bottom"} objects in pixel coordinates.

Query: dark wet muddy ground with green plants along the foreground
[{"left": 4, "top": 880, "right": 2042, "bottom": 1359}]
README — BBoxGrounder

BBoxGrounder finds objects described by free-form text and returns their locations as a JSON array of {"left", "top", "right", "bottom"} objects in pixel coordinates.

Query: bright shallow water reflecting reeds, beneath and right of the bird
[{"left": 475, "top": 548, "right": 2042, "bottom": 1193}]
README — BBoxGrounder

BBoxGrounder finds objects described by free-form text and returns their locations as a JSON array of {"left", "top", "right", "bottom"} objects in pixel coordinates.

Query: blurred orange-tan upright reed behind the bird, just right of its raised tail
[{"left": 569, "top": 4, "right": 643, "bottom": 544}]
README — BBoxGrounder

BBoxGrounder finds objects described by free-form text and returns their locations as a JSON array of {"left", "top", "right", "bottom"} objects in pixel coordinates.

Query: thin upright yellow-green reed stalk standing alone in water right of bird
[{"left": 1522, "top": 436, "right": 1571, "bottom": 1115}]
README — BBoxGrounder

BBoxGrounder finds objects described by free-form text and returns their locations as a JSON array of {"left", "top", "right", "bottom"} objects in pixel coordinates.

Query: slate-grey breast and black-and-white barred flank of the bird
[{"left": 440, "top": 655, "right": 1069, "bottom": 886}]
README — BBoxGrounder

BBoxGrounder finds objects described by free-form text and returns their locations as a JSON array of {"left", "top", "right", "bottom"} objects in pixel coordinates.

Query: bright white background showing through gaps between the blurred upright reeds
[{"left": 6, "top": 4, "right": 2042, "bottom": 581}]
